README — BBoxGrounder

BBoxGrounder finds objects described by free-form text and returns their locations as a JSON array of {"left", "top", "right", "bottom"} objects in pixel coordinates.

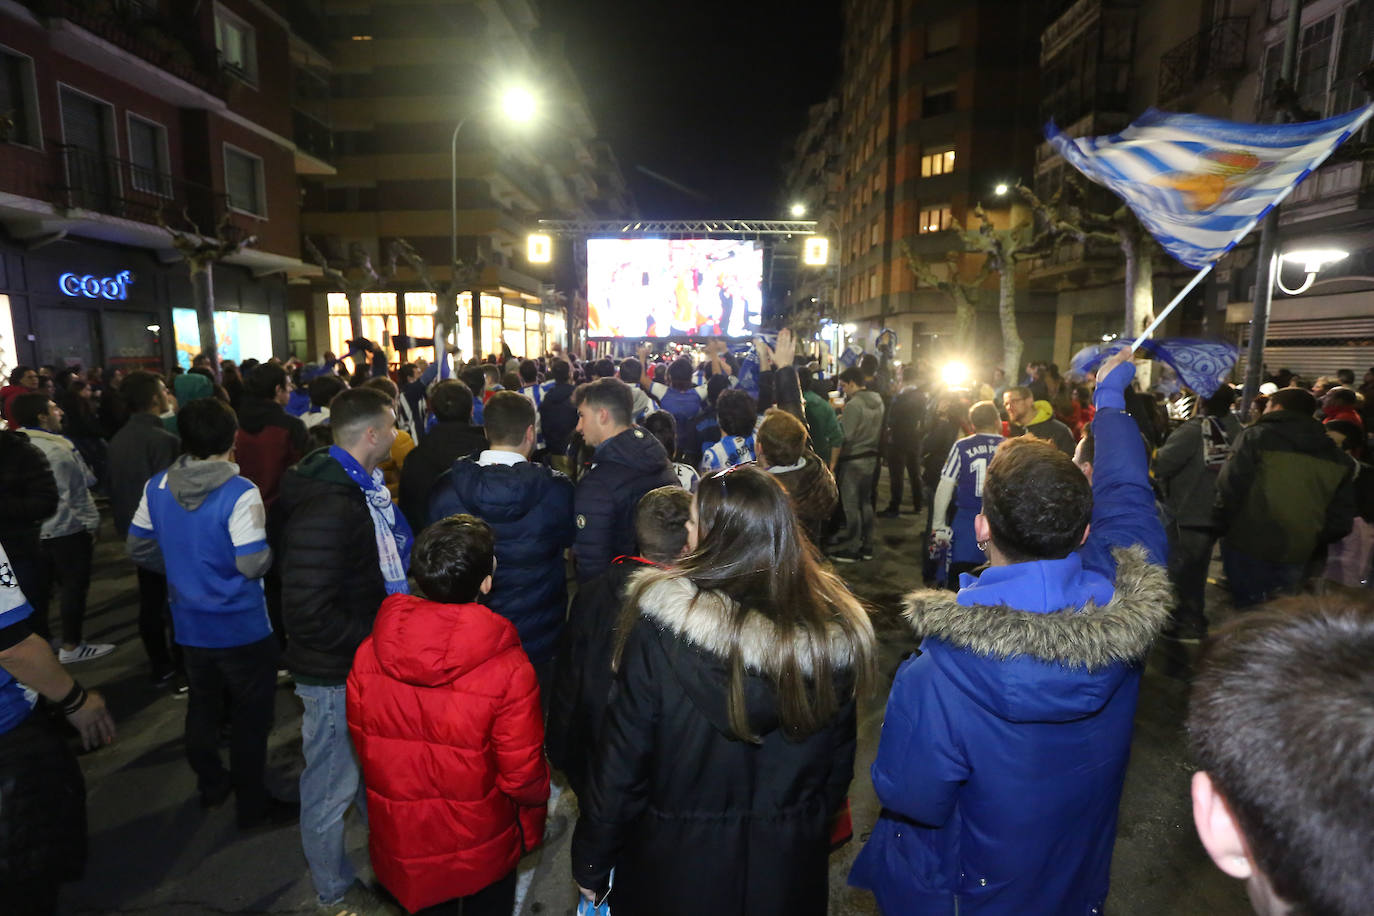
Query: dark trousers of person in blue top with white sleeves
[{"left": 183, "top": 636, "right": 279, "bottom": 818}]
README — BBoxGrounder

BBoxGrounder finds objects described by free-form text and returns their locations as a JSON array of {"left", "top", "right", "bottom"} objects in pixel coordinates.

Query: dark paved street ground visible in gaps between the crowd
[{"left": 48, "top": 501, "right": 1250, "bottom": 916}]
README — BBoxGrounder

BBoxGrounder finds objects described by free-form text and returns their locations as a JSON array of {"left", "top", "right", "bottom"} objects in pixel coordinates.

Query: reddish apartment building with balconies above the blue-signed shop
[{"left": 0, "top": 0, "right": 331, "bottom": 369}]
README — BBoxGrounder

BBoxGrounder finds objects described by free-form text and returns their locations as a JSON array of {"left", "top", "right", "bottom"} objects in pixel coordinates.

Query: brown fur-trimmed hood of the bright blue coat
[{"left": 905, "top": 547, "right": 1173, "bottom": 721}]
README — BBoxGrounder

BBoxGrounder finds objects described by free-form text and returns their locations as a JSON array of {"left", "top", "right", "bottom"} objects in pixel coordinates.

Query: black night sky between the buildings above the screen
[{"left": 540, "top": 0, "right": 841, "bottom": 218}]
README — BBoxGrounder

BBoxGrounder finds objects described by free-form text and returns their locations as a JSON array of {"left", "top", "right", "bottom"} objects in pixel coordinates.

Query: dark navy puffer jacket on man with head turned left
[{"left": 568, "top": 428, "right": 677, "bottom": 582}]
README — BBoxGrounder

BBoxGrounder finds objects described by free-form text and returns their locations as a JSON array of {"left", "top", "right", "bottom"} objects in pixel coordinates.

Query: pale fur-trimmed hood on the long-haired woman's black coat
[{"left": 628, "top": 569, "right": 875, "bottom": 735}]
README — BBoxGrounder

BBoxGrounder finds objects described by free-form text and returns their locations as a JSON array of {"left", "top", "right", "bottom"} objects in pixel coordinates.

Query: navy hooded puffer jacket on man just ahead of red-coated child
[{"left": 430, "top": 457, "right": 576, "bottom": 665}]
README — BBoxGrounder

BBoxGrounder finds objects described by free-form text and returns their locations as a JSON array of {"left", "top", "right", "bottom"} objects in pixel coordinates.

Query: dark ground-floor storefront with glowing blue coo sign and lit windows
[{"left": 0, "top": 239, "right": 286, "bottom": 371}]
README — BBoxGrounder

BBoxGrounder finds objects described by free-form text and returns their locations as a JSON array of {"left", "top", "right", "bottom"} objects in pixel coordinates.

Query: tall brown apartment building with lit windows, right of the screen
[{"left": 835, "top": 0, "right": 1038, "bottom": 373}]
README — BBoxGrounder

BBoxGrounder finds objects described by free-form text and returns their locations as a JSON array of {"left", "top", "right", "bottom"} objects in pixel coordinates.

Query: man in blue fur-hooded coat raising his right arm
[{"left": 849, "top": 350, "right": 1172, "bottom": 916}]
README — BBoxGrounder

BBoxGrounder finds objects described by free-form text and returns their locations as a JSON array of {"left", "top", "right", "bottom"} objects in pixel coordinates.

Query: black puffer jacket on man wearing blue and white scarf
[{"left": 271, "top": 449, "right": 386, "bottom": 684}]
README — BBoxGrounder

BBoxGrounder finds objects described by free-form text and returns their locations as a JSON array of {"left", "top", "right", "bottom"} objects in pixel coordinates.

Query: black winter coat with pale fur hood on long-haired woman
[{"left": 572, "top": 570, "right": 856, "bottom": 916}]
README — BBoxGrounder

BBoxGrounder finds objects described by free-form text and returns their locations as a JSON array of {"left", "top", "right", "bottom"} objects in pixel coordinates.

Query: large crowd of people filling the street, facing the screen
[{"left": 0, "top": 331, "right": 1374, "bottom": 916}]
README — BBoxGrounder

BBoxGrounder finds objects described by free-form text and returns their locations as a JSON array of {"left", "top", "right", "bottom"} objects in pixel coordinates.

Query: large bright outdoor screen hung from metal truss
[{"left": 587, "top": 239, "right": 764, "bottom": 338}]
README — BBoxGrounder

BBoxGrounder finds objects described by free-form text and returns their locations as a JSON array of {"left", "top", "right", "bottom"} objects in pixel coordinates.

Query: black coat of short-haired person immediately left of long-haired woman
[{"left": 544, "top": 556, "right": 651, "bottom": 798}]
